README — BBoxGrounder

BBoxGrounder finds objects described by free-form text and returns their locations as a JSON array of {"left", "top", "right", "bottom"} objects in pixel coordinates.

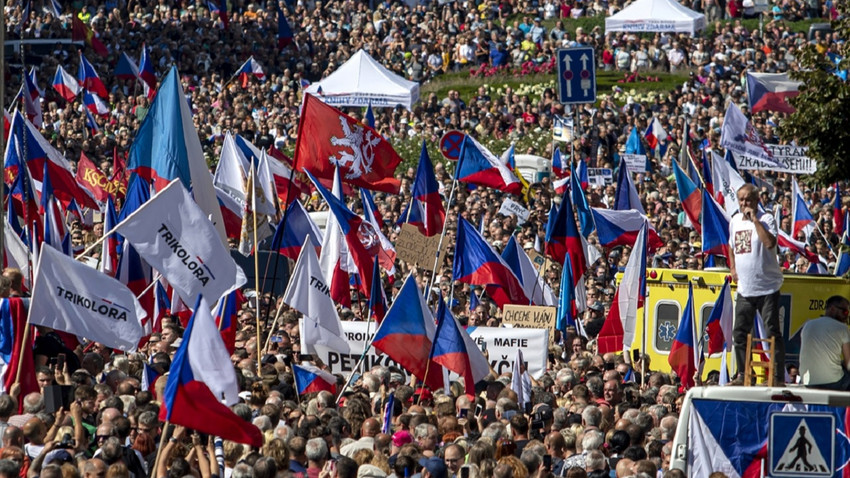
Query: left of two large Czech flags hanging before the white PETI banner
[{"left": 372, "top": 274, "right": 443, "bottom": 390}]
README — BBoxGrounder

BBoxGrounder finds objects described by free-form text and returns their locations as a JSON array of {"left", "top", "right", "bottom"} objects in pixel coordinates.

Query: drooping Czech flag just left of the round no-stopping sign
[{"left": 401, "top": 140, "right": 446, "bottom": 237}]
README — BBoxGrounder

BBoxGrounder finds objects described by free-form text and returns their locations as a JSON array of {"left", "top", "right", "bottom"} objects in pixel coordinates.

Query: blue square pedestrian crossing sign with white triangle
[{"left": 767, "top": 412, "right": 835, "bottom": 478}]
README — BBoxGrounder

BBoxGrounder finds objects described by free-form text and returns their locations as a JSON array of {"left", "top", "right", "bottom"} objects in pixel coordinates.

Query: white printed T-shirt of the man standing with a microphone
[{"left": 729, "top": 213, "right": 782, "bottom": 297}]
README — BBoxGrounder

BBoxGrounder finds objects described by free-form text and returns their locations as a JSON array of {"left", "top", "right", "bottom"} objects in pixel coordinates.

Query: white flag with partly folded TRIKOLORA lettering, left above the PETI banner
[{"left": 283, "top": 237, "right": 350, "bottom": 354}]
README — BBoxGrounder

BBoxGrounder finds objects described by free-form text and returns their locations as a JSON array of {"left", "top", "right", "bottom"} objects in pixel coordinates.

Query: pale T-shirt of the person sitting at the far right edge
[{"left": 800, "top": 317, "right": 850, "bottom": 385}]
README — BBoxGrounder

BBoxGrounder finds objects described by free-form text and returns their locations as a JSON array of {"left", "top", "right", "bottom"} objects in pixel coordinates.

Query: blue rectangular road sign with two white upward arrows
[{"left": 558, "top": 47, "right": 596, "bottom": 105}]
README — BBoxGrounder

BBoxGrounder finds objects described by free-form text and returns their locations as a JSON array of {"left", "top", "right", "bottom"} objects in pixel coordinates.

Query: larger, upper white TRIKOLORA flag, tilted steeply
[{"left": 116, "top": 181, "right": 246, "bottom": 304}]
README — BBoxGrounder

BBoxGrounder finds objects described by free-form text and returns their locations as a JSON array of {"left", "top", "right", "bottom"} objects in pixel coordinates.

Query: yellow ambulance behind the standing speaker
[{"left": 631, "top": 268, "right": 850, "bottom": 378}]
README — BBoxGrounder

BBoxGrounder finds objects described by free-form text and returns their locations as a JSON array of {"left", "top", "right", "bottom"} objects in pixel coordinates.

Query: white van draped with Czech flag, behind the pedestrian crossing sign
[{"left": 670, "top": 386, "right": 850, "bottom": 478}]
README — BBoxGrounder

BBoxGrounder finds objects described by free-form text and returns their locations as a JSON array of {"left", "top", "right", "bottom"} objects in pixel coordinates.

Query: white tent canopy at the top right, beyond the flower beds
[{"left": 605, "top": 0, "right": 705, "bottom": 35}]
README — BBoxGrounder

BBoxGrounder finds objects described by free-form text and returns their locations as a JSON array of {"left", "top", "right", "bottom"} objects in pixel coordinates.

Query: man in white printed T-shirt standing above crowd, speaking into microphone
[{"left": 729, "top": 184, "right": 785, "bottom": 386}]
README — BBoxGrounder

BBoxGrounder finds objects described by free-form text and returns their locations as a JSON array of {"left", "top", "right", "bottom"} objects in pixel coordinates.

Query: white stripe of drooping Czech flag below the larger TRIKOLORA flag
[{"left": 183, "top": 296, "right": 239, "bottom": 406}]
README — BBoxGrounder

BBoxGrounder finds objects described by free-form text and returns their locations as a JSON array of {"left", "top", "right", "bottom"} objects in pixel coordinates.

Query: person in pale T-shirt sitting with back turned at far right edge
[{"left": 800, "top": 295, "right": 850, "bottom": 391}]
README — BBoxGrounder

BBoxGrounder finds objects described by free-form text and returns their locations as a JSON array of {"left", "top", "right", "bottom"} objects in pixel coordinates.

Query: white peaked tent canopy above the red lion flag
[{"left": 306, "top": 50, "right": 419, "bottom": 110}]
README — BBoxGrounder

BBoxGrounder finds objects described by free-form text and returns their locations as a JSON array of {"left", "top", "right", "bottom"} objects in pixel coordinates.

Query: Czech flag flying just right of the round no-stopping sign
[{"left": 455, "top": 135, "right": 522, "bottom": 195}]
